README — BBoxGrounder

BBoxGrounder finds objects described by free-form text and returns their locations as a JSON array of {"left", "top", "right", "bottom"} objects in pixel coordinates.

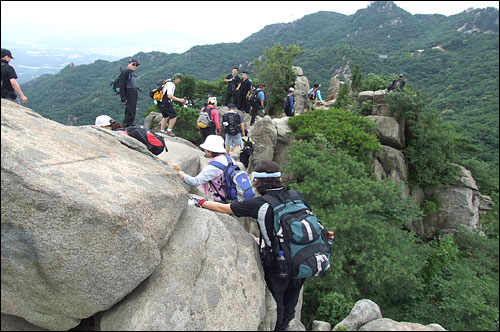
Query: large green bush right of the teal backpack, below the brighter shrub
[{"left": 285, "top": 138, "right": 425, "bottom": 324}]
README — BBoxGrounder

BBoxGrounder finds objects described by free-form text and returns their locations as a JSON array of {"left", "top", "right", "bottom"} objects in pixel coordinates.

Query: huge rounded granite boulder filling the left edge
[{"left": 1, "top": 99, "right": 187, "bottom": 330}]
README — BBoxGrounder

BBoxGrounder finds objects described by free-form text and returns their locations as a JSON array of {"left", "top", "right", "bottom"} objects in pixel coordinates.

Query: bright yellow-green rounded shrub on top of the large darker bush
[{"left": 288, "top": 108, "right": 380, "bottom": 163}]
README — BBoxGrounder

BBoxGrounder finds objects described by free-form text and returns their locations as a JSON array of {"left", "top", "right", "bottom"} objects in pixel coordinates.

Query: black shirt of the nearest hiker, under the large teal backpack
[{"left": 231, "top": 188, "right": 311, "bottom": 246}]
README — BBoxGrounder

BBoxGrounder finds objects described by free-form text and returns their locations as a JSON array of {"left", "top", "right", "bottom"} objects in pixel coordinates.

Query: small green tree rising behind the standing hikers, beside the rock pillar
[{"left": 253, "top": 43, "right": 303, "bottom": 115}]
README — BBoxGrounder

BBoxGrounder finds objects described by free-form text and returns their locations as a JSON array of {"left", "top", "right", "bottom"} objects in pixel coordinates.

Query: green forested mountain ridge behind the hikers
[{"left": 22, "top": 2, "right": 499, "bottom": 165}]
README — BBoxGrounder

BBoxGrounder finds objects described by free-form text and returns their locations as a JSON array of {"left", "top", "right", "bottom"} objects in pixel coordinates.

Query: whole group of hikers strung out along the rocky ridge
[{"left": 2, "top": 49, "right": 404, "bottom": 331}]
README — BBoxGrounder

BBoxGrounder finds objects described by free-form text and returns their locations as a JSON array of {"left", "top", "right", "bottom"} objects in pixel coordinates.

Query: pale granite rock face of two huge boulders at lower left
[{"left": 1, "top": 100, "right": 266, "bottom": 330}]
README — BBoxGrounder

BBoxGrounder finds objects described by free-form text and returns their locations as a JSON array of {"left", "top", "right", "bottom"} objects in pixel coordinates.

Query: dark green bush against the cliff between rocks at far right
[{"left": 403, "top": 110, "right": 460, "bottom": 187}]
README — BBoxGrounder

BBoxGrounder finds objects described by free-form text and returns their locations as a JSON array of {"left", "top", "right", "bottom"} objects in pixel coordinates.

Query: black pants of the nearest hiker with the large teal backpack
[{"left": 264, "top": 264, "right": 305, "bottom": 331}]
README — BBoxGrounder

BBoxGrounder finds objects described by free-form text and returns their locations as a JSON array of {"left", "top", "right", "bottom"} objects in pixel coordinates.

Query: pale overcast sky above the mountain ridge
[{"left": 1, "top": 1, "right": 498, "bottom": 57}]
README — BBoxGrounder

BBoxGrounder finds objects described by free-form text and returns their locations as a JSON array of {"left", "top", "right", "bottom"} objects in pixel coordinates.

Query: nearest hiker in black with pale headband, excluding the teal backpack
[{"left": 189, "top": 161, "right": 310, "bottom": 331}]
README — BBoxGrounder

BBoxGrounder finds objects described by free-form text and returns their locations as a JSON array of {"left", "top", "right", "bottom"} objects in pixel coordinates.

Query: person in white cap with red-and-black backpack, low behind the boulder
[{"left": 94, "top": 115, "right": 168, "bottom": 155}]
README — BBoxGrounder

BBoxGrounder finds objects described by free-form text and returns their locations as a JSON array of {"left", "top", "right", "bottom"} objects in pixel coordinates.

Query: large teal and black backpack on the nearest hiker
[{"left": 261, "top": 190, "right": 331, "bottom": 279}]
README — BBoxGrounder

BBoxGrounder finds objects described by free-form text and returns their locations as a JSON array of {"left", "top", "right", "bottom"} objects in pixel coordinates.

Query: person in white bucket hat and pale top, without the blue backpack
[{"left": 173, "top": 135, "right": 234, "bottom": 202}]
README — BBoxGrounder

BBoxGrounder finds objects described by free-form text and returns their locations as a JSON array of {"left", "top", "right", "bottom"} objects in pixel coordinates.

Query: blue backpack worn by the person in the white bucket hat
[{"left": 209, "top": 154, "right": 255, "bottom": 202}]
